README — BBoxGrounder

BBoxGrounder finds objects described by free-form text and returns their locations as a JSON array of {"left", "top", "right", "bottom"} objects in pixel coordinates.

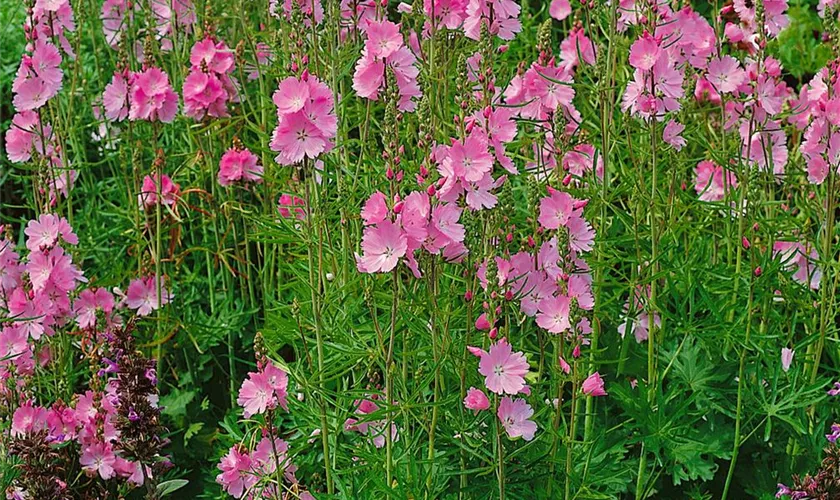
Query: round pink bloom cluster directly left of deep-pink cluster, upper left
[{"left": 128, "top": 68, "right": 178, "bottom": 123}]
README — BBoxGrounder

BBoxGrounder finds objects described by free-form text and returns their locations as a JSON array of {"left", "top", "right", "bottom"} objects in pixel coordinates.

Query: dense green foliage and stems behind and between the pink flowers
[{"left": 0, "top": 0, "right": 840, "bottom": 499}]
